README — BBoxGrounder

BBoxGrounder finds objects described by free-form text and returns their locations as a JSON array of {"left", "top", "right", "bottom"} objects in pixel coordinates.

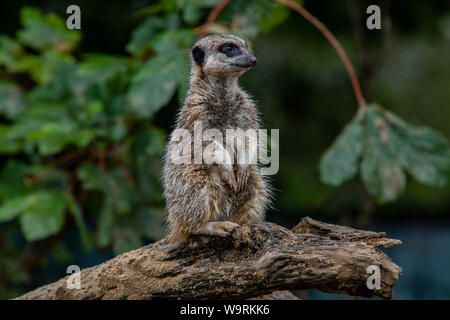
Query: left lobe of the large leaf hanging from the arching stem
[{"left": 320, "top": 114, "right": 363, "bottom": 186}]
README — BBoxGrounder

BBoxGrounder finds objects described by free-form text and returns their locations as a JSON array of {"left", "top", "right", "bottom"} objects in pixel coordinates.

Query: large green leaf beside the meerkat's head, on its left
[{"left": 127, "top": 51, "right": 188, "bottom": 118}]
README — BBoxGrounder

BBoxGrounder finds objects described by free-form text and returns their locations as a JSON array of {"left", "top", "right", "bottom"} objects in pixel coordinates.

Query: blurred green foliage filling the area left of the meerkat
[{"left": 0, "top": 0, "right": 287, "bottom": 296}]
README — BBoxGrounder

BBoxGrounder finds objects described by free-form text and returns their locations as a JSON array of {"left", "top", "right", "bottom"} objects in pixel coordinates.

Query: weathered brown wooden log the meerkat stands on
[{"left": 17, "top": 217, "right": 402, "bottom": 299}]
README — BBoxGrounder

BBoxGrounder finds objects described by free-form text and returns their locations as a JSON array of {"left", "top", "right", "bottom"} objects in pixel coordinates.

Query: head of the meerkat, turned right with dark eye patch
[{"left": 191, "top": 34, "right": 256, "bottom": 78}]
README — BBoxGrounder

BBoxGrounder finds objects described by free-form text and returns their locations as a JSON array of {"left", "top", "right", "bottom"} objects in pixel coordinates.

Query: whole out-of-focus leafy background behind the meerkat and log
[{"left": 0, "top": 0, "right": 450, "bottom": 299}]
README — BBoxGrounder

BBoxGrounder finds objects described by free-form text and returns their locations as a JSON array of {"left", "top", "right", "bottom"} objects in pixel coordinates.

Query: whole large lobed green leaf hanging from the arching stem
[{"left": 320, "top": 104, "right": 450, "bottom": 203}]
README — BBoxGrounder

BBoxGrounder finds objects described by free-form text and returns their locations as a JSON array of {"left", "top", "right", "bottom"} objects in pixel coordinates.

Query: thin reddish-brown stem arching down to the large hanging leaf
[{"left": 275, "top": 0, "right": 366, "bottom": 108}]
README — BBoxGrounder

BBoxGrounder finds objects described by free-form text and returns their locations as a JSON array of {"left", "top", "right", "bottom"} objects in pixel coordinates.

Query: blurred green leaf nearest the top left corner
[{"left": 17, "top": 7, "right": 81, "bottom": 51}]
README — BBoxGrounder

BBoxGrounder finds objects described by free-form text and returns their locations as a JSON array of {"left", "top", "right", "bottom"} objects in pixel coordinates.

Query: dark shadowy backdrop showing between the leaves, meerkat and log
[{"left": 0, "top": 0, "right": 450, "bottom": 299}]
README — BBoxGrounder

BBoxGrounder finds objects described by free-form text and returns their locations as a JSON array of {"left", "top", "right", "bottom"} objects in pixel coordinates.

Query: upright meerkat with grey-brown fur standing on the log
[{"left": 163, "top": 34, "right": 270, "bottom": 242}]
